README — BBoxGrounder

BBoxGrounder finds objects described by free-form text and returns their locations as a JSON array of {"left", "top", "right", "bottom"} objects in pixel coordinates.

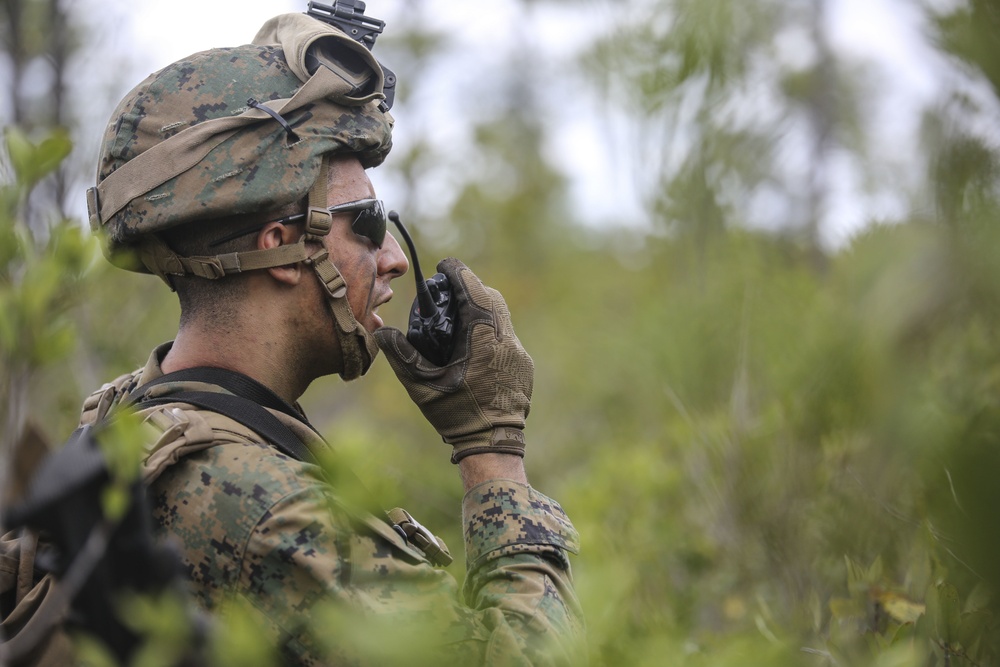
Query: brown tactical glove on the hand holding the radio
[{"left": 375, "top": 258, "right": 535, "bottom": 463}]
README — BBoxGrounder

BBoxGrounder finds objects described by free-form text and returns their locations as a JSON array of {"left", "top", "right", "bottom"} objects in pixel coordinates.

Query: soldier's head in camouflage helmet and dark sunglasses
[{"left": 88, "top": 14, "right": 406, "bottom": 378}]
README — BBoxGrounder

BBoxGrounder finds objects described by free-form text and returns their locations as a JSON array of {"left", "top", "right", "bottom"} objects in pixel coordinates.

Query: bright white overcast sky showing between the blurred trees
[{"left": 68, "top": 0, "right": 940, "bottom": 244}]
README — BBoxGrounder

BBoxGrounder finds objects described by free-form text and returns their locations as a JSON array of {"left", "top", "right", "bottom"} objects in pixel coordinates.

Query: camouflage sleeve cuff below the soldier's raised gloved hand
[{"left": 462, "top": 480, "right": 580, "bottom": 570}]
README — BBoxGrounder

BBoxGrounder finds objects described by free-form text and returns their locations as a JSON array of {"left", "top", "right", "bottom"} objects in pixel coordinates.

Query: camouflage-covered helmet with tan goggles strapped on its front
[{"left": 87, "top": 14, "right": 393, "bottom": 277}]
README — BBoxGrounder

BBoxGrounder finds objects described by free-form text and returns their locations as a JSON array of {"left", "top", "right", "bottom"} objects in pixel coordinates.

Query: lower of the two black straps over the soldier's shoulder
[{"left": 136, "top": 392, "right": 318, "bottom": 463}]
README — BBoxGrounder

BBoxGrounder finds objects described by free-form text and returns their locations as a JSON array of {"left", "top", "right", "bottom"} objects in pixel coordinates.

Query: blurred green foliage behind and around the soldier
[{"left": 9, "top": 0, "right": 1000, "bottom": 667}]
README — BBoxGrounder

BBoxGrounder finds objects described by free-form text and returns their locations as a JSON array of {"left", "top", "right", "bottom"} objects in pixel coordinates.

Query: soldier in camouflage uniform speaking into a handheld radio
[{"left": 81, "top": 7, "right": 586, "bottom": 665}]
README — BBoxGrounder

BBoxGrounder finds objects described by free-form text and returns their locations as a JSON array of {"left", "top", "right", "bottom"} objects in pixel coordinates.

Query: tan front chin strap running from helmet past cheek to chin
[{"left": 303, "top": 157, "right": 378, "bottom": 380}]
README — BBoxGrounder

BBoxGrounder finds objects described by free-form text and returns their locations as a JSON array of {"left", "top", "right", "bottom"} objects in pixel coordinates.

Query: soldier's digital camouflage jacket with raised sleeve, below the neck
[{"left": 82, "top": 346, "right": 586, "bottom": 665}]
